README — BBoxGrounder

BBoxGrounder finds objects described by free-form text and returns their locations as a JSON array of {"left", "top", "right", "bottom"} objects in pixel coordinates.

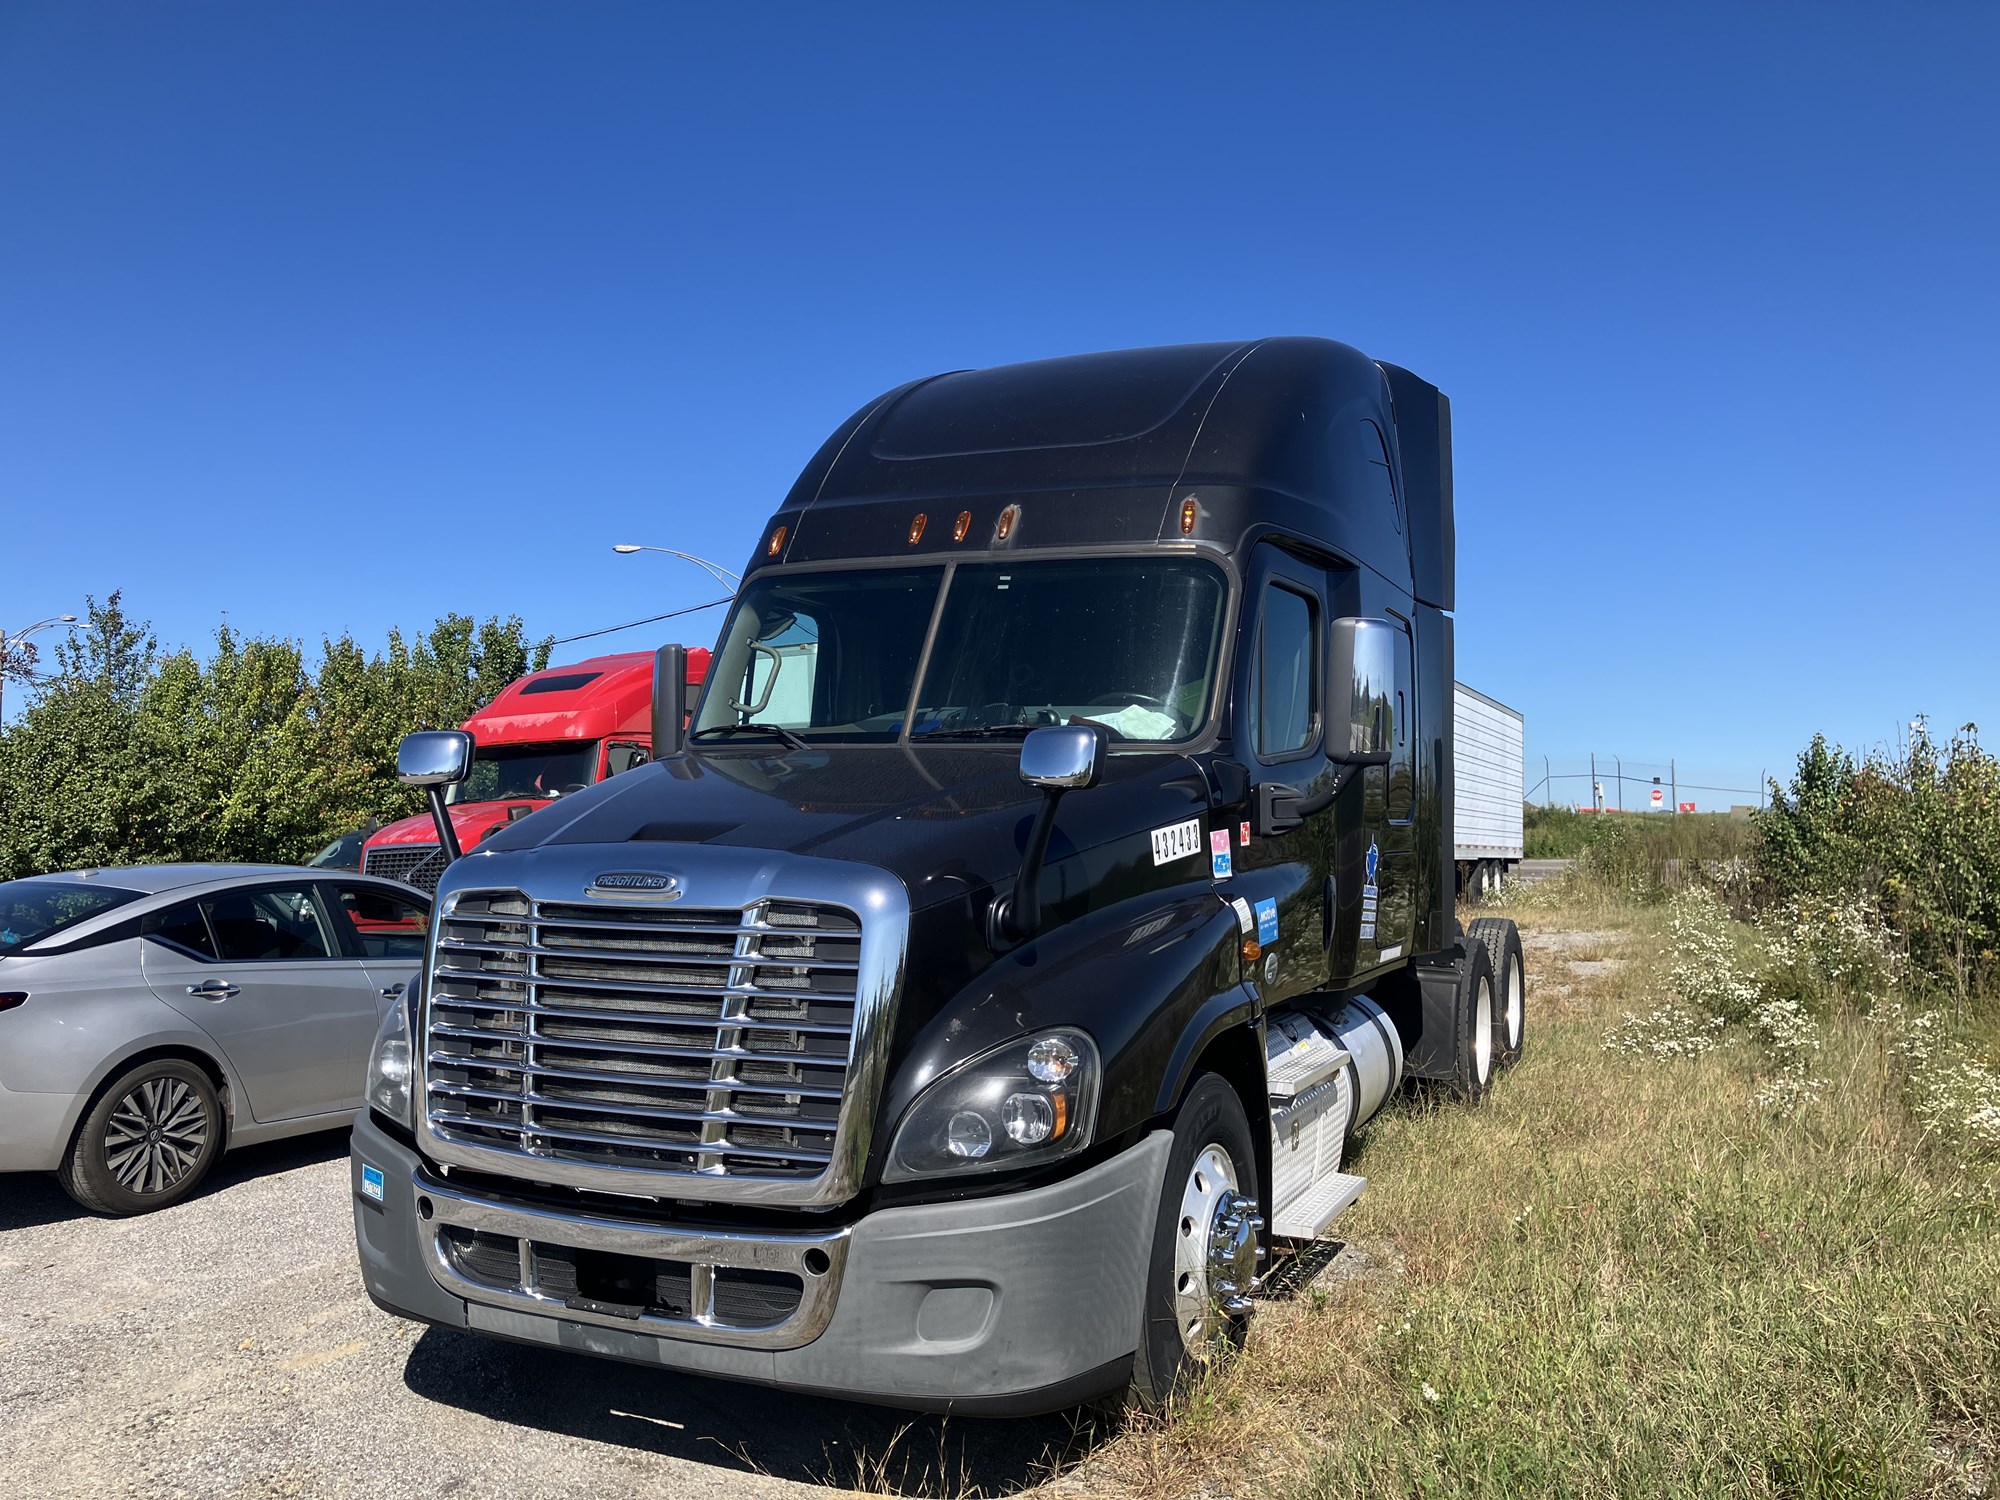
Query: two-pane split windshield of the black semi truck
[{"left": 694, "top": 556, "right": 1228, "bottom": 744}]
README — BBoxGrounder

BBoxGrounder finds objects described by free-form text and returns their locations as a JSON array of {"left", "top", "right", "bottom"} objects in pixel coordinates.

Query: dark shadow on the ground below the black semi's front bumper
[{"left": 404, "top": 1328, "right": 1116, "bottom": 1500}]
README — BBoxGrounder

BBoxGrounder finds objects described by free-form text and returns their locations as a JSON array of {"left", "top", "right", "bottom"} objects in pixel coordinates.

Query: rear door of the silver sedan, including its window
[{"left": 140, "top": 880, "right": 380, "bottom": 1124}]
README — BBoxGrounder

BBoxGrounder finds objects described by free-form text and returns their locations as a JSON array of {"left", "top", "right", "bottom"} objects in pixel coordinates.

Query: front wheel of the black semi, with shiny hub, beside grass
[{"left": 1130, "top": 1072, "right": 1264, "bottom": 1412}]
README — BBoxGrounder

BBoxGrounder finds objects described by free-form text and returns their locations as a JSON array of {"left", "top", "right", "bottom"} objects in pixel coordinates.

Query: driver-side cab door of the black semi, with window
[{"left": 1222, "top": 546, "right": 1336, "bottom": 1004}]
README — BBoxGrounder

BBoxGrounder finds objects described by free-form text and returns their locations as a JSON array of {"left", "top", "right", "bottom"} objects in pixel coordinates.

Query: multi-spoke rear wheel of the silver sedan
[{"left": 56, "top": 1058, "right": 222, "bottom": 1218}]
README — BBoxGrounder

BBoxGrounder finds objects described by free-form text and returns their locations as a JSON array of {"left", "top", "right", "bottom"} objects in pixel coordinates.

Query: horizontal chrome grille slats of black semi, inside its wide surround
[{"left": 424, "top": 890, "right": 862, "bottom": 1196}]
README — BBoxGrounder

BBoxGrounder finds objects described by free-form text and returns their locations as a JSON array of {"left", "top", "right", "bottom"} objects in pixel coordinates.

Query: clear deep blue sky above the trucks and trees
[{"left": 0, "top": 0, "right": 2000, "bottom": 804}]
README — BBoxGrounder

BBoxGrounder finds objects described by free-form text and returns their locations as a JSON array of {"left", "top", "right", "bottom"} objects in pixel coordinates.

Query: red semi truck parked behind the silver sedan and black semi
[{"left": 362, "top": 650, "right": 708, "bottom": 890}]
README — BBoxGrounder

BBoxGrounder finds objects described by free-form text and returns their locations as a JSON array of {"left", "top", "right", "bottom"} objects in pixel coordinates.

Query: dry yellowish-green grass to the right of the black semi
[{"left": 1096, "top": 892, "right": 2000, "bottom": 1496}]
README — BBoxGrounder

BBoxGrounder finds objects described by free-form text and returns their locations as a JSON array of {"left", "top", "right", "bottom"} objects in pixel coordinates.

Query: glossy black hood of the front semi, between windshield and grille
[{"left": 480, "top": 742, "right": 1210, "bottom": 908}]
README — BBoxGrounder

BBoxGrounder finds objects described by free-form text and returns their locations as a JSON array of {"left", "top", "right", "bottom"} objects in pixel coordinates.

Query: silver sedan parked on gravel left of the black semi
[{"left": 0, "top": 864, "right": 430, "bottom": 1214}]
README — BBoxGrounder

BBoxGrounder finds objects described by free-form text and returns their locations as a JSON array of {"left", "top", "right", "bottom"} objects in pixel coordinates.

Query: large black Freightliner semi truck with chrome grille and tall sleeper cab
[{"left": 352, "top": 338, "right": 1526, "bottom": 1412}]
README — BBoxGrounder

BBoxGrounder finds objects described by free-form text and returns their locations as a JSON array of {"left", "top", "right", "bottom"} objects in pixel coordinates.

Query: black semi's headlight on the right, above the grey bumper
[{"left": 882, "top": 1028, "right": 1100, "bottom": 1182}]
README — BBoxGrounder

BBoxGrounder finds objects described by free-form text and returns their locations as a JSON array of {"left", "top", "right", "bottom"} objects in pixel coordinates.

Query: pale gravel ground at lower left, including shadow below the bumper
[{"left": 0, "top": 1132, "right": 1090, "bottom": 1500}]
